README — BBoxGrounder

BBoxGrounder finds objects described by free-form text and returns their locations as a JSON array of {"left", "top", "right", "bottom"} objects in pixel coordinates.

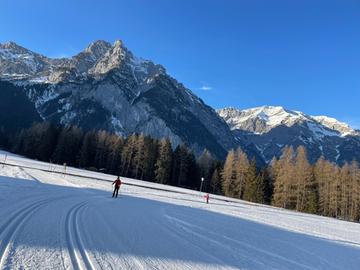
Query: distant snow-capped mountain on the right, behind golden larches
[{"left": 217, "top": 106, "right": 360, "bottom": 164}]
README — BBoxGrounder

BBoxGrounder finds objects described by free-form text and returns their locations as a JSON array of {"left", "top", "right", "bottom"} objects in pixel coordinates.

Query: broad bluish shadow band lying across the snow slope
[{"left": 0, "top": 177, "right": 360, "bottom": 269}]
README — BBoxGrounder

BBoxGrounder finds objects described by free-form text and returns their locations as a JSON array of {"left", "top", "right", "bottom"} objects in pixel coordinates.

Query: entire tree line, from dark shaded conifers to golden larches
[{"left": 3, "top": 123, "right": 360, "bottom": 221}]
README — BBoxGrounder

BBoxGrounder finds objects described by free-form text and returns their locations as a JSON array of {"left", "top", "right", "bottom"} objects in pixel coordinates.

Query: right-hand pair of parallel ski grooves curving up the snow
[{"left": 65, "top": 201, "right": 96, "bottom": 270}]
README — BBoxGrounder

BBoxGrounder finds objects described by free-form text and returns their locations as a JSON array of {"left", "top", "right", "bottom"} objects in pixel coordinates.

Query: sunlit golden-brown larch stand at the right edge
[{"left": 221, "top": 146, "right": 360, "bottom": 221}]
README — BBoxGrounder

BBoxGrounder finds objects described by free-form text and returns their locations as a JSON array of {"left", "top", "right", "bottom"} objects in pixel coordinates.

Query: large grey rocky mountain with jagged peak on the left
[{"left": 0, "top": 40, "right": 236, "bottom": 157}]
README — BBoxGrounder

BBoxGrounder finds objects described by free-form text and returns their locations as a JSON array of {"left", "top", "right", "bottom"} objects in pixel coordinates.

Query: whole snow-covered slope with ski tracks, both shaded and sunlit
[{"left": 0, "top": 152, "right": 360, "bottom": 270}]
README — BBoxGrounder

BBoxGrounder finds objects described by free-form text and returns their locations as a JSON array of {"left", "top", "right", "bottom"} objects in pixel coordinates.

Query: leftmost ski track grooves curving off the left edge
[{"left": 0, "top": 197, "right": 67, "bottom": 269}]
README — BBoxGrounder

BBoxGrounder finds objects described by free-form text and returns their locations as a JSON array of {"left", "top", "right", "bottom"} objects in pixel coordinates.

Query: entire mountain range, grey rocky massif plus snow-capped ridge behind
[{"left": 0, "top": 40, "right": 360, "bottom": 164}]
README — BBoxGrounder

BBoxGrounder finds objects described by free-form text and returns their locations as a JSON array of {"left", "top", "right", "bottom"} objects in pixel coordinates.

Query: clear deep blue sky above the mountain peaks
[{"left": 0, "top": 0, "right": 360, "bottom": 128}]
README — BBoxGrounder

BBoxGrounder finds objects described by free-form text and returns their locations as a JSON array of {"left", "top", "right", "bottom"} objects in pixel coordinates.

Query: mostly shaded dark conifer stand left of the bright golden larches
[{"left": 7, "top": 123, "right": 218, "bottom": 190}]
